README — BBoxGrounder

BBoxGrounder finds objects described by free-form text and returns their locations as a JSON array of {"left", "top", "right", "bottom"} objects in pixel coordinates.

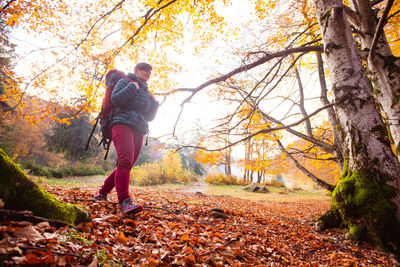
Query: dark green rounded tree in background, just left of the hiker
[{"left": 47, "top": 110, "right": 93, "bottom": 167}]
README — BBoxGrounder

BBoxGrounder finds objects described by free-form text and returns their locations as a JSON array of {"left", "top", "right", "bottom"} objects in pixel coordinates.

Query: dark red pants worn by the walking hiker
[{"left": 99, "top": 124, "right": 143, "bottom": 205}]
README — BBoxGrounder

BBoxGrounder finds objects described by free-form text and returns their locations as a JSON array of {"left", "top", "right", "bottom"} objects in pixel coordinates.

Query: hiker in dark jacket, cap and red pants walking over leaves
[{"left": 95, "top": 62, "right": 158, "bottom": 214}]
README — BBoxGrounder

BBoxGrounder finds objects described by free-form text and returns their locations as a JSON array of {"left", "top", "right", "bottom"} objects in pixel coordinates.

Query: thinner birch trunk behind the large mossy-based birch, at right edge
[{"left": 351, "top": 0, "right": 400, "bottom": 155}]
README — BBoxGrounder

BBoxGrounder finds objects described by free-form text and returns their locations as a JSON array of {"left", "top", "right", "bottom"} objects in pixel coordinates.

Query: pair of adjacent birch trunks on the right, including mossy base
[{"left": 314, "top": 0, "right": 400, "bottom": 259}]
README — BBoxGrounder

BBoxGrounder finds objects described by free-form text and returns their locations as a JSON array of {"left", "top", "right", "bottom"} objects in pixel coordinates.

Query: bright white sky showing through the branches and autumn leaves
[{"left": 10, "top": 0, "right": 324, "bottom": 159}]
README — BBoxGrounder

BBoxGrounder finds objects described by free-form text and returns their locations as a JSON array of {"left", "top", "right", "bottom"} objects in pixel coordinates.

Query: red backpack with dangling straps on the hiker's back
[{"left": 85, "top": 69, "right": 127, "bottom": 159}]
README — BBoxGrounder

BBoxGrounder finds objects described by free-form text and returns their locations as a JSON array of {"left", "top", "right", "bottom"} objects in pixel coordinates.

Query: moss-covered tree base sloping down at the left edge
[{"left": 0, "top": 149, "right": 91, "bottom": 225}]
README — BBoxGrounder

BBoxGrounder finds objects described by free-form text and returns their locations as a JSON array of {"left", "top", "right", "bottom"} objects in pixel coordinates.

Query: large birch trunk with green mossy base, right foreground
[{"left": 314, "top": 0, "right": 400, "bottom": 258}]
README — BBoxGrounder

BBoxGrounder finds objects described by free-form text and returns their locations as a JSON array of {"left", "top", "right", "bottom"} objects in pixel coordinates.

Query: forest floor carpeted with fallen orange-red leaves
[{"left": 0, "top": 179, "right": 395, "bottom": 266}]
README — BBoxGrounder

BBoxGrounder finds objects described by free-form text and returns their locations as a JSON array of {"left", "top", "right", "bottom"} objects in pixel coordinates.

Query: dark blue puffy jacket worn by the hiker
[{"left": 111, "top": 73, "right": 158, "bottom": 135}]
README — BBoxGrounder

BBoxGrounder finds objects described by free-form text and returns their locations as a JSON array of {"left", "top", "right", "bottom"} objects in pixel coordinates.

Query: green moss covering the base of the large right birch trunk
[{"left": 331, "top": 163, "right": 400, "bottom": 257}]
